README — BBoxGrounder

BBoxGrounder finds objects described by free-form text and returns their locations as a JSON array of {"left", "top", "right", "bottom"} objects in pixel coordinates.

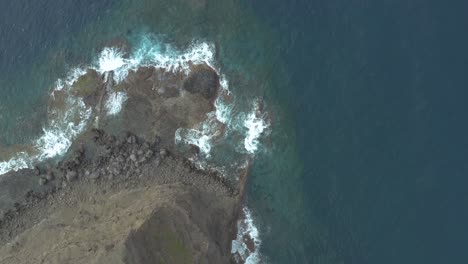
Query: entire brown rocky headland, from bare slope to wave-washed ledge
[{"left": 0, "top": 60, "right": 255, "bottom": 264}]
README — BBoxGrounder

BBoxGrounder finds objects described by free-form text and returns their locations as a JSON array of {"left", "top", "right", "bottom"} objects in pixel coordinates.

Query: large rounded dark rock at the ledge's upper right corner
[{"left": 183, "top": 64, "right": 219, "bottom": 99}]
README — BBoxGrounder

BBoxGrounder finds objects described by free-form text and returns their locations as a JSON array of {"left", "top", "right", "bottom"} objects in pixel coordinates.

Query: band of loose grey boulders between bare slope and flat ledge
[{"left": 34, "top": 129, "right": 169, "bottom": 187}]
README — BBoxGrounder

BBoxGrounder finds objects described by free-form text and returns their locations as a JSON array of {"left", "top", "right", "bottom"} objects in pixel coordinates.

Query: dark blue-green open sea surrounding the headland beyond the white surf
[{"left": 0, "top": 0, "right": 468, "bottom": 264}]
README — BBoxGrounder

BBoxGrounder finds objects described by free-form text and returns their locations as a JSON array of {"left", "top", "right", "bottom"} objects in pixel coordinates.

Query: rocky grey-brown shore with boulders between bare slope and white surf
[{"left": 0, "top": 57, "right": 255, "bottom": 263}]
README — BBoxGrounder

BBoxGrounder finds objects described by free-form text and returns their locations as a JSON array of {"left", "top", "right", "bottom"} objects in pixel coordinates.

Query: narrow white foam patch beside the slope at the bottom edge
[{"left": 231, "top": 207, "right": 262, "bottom": 264}]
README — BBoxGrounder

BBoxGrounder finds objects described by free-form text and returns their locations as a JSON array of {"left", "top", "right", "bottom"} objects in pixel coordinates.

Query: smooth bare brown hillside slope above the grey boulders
[{"left": 0, "top": 184, "right": 236, "bottom": 264}]
